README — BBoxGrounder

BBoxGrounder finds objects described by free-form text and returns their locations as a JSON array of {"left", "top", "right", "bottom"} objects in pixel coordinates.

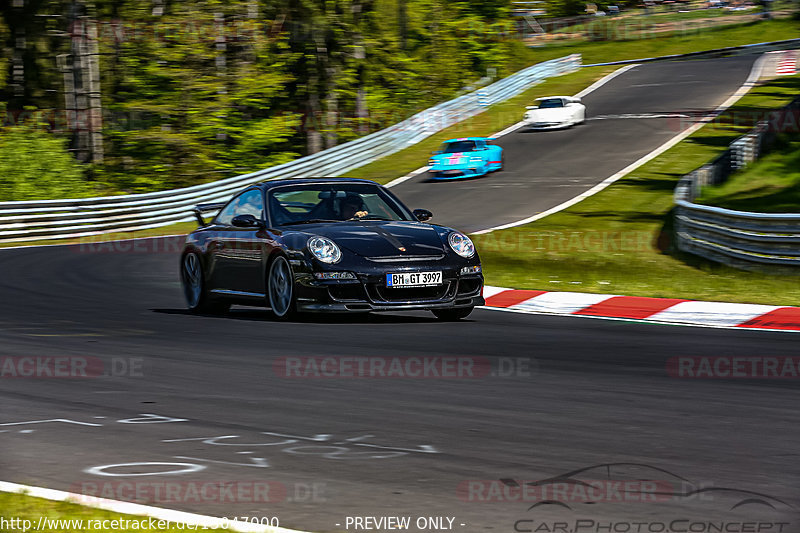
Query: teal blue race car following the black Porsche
[{"left": 428, "top": 137, "right": 503, "bottom": 180}]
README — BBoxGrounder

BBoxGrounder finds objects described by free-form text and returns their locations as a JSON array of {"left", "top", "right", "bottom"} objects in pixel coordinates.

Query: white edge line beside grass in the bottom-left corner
[{"left": 0, "top": 481, "right": 308, "bottom": 533}]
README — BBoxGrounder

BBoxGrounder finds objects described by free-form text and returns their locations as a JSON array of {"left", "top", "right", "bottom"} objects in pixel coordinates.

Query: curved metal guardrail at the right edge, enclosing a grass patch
[{"left": 674, "top": 93, "right": 800, "bottom": 270}]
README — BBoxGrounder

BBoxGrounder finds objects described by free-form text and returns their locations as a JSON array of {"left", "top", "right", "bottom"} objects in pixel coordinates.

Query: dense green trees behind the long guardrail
[{"left": 0, "top": 0, "right": 529, "bottom": 200}]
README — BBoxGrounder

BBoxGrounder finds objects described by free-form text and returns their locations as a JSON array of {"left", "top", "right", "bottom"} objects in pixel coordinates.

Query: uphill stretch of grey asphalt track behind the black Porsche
[{"left": 392, "top": 56, "right": 757, "bottom": 232}]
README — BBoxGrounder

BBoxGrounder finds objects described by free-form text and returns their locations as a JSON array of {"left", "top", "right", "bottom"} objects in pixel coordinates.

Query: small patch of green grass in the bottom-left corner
[{"left": 0, "top": 493, "right": 192, "bottom": 533}]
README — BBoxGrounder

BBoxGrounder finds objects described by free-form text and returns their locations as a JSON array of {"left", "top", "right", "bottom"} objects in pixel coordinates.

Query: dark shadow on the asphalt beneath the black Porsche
[{"left": 150, "top": 307, "right": 450, "bottom": 324}]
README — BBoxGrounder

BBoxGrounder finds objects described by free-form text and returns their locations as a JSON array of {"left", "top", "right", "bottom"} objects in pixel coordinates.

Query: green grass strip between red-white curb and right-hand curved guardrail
[{"left": 475, "top": 72, "right": 800, "bottom": 305}]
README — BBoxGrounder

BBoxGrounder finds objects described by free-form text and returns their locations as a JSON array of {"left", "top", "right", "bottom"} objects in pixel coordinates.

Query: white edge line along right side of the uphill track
[{"left": 471, "top": 55, "right": 764, "bottom": 235}]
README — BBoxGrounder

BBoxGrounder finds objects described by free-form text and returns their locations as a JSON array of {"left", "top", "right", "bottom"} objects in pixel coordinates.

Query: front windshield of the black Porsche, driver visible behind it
[{"left": 269, "top": 183, "right": 415, "bottom": 226}]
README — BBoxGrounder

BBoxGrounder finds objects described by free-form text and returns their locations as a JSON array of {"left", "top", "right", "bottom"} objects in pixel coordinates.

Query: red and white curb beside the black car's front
[{"left": 483, "top": 286, "right": 800, "bottom": 331}]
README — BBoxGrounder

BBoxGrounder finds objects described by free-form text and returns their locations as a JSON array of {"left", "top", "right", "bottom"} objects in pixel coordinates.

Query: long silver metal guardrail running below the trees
[{"left": 0, "top": 54, "right": 581, "bottom": 243}]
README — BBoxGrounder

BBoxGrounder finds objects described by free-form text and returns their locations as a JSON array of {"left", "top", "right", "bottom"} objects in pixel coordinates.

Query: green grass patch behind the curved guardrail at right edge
[{"left": 697, "top": 130, "right": 800, "bottom": 213}]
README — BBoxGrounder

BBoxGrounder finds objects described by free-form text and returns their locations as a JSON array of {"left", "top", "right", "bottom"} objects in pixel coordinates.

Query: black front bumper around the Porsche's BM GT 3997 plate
[{"left": 295, "top": 262, "right": 485, "bottom": 313}]
